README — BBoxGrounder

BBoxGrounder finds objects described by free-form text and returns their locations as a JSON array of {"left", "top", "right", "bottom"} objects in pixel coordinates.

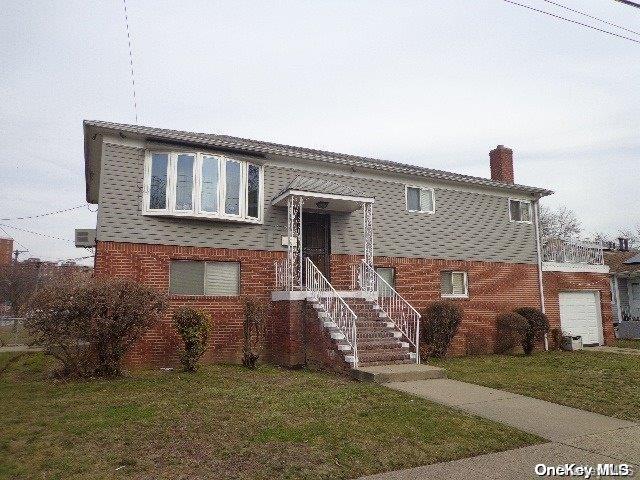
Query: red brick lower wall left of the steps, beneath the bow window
[{"left": 95, "top": 242, "right": 284, "bottom": 368}]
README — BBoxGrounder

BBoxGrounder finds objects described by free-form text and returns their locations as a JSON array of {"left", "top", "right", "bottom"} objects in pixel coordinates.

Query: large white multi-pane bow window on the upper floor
[{"left": 142, "top": 152, "right": 264, "bottom": 223}]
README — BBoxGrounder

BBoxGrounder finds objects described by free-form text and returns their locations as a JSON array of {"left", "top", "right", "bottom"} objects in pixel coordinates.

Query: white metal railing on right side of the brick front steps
[{"left": 351, "top": 260, "right": 420, "bottom": 363}]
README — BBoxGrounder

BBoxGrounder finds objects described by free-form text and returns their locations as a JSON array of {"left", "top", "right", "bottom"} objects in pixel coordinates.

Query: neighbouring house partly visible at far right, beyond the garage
[{"left": 604, "top": 244, "right": 640, "bottom": 338}]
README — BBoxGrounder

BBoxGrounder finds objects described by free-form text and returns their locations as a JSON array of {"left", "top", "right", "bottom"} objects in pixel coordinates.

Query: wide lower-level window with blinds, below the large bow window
[{"left": 169, "top": 260, "right": 240, "bottom": 296}]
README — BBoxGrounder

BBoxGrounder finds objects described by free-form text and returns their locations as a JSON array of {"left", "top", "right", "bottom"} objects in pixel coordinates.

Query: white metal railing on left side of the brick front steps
[{"left": 305, "top": 257, "right": 358, "bottom": 367}]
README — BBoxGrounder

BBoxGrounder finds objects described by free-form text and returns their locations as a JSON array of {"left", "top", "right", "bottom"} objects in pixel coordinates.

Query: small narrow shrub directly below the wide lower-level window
[{"left": 173, "top": 307, "right": 209, "bottom": 372}]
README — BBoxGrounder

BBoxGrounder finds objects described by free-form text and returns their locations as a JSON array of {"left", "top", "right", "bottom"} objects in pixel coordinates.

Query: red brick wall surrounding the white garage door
[{"left": 542, "top": 272, "right": 614, "bottom": 344}]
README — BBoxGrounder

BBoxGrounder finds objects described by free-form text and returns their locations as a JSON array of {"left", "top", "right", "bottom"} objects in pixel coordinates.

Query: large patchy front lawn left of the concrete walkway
[{"left": 0, "top": 354, "right": 541, "bottom": 479}]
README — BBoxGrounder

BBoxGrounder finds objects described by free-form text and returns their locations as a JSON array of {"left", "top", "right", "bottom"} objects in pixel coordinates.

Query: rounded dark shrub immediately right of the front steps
[{"left": 420, "top": 301, "right": 462, "bottom": 358}]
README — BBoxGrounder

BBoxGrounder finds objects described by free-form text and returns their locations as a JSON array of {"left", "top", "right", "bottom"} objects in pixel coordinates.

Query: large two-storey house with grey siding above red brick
[{"left": 84, "top": 121, "right": 613, "bottom": 370}]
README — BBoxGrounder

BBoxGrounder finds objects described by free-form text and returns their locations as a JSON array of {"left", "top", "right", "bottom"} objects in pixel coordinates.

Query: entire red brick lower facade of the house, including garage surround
[{"left": 95, "top": 242, "right": 613, "bottom": 372}]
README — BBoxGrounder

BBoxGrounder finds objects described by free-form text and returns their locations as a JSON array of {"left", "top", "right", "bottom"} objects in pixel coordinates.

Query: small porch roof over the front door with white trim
[{"left": 271, "top": 176, "right": 374, "bottom": 212}]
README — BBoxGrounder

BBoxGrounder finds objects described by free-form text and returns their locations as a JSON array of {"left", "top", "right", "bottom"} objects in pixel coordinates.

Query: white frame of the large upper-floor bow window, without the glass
[{"left": 142, "top": 150, "right": 264, "bottom": 224}]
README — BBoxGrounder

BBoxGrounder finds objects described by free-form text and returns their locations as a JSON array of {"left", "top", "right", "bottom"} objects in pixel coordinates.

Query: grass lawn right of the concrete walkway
[{"left": 433, "top": 351, "right": 640, "bottom": 421}]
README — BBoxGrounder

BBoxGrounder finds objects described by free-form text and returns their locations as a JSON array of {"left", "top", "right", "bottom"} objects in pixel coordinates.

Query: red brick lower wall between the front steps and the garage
[{"left": 331, "top": 255, "right": 541, "bottom": 355}]
